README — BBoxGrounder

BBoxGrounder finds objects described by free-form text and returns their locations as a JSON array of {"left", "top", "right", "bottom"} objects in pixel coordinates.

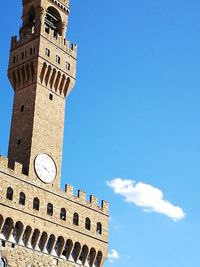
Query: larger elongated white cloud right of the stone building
[{"left": 107, "top": 178, "right": 185, "bottom": 221}]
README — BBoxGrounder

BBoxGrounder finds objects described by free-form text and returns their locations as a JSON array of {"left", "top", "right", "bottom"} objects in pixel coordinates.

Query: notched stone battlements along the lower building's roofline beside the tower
[{"left": 0, "top": 156, "right": 109, "bottom": 215}]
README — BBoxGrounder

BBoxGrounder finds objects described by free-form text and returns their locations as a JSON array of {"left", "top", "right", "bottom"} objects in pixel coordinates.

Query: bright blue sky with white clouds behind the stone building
[{"left": 0, "top": 0, "right": 200, "bottom": 267}]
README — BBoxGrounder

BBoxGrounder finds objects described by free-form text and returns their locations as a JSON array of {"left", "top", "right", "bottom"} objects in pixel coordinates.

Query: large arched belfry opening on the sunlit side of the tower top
[{"left": 45, "top": 7, "right": 62, "bottom": 38}]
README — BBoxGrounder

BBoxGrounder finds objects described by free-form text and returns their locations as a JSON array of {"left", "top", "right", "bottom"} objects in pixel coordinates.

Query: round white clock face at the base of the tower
[{"left": 35, "top": 154, "right": 56, "bottom": 184}]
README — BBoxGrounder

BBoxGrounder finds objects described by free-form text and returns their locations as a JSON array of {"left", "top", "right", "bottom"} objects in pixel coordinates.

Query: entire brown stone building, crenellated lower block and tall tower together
[{"left": 0, "top": 0, "right": 109, "bottom": 267}]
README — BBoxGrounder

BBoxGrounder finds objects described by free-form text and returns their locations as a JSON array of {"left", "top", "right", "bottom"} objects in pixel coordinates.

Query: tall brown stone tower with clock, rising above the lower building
[{"left": 8, "top": 0, "right": 77, "bottom": 187}]
